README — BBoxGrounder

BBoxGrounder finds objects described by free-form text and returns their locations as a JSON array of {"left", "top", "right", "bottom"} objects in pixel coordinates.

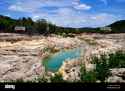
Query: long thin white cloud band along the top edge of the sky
[{"left": 8, "top": 0, "right": 91, "bottom": 12}]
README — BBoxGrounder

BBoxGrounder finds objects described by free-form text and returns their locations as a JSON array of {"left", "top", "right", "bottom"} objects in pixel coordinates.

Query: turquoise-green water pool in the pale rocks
[{"left": 43, "top": 48, "right": 81, "bottom": 72}]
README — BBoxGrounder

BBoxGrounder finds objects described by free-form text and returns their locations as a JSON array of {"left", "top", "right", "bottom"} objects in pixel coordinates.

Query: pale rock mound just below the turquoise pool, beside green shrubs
[{"left": 58, "top": 59, "right": 81, "bottom": 82}]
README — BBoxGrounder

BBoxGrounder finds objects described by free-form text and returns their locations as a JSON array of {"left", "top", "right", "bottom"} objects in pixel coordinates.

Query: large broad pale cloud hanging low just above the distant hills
[{"left": 32, "top": 8, "right": 118, "bottom": 27}]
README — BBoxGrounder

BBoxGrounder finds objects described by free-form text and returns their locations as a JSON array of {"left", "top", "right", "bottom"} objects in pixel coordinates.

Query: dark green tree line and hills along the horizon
[{"left": 0, "top": 15, "right": 125, "bottom": 35}]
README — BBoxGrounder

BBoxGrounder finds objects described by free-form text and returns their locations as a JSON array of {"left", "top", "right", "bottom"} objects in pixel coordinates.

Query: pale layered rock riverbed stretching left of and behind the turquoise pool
[{"left": 0, "top": 33, "right": 125, "bottom": 81}]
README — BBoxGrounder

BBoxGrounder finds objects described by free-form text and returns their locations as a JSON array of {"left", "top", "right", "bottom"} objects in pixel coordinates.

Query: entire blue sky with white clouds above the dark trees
[{"left": 0, "top": 0, "right": 125, "bottom": 27}]
